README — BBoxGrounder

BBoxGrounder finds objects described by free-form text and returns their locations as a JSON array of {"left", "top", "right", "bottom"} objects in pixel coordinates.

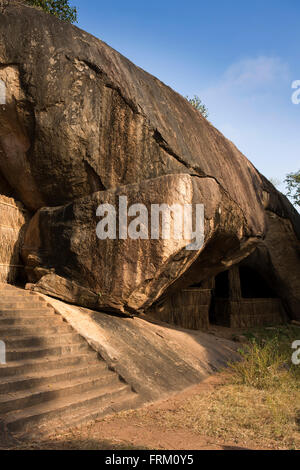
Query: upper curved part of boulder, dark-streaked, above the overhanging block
[{"left": 0, "top": 2, "right": 264, "bottom": 227}]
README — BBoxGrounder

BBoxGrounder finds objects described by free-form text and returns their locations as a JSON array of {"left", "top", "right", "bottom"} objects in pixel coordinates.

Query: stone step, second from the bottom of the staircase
[{"left": 0, "top": 371, "right": 123, "bottom": 414}]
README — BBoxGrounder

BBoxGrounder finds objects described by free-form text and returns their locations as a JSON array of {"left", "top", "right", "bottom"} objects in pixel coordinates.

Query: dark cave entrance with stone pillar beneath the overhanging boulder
[{"left": 149, "top": 265, "right": 285, "bottom": 330}]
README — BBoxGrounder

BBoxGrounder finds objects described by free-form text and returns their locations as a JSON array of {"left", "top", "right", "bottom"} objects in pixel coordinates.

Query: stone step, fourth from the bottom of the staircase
[{"left": 0, "top": 351, "right": 101, "bottom": 377}]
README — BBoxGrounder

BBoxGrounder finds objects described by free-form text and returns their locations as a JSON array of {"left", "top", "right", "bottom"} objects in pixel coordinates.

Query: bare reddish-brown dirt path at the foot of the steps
[{"left": 32, "top": 374, "right": 256, "bottom": 450}]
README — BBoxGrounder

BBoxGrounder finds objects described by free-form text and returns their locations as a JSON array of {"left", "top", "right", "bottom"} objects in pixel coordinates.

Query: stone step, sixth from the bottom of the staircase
[{"left": 5, "top": 332, "right": 86, "bottom": 349}]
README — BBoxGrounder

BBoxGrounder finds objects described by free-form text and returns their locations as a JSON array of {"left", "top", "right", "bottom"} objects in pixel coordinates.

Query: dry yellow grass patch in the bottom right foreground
[{"left": 130, "top": 376, "right": 300, "bottom": 449}]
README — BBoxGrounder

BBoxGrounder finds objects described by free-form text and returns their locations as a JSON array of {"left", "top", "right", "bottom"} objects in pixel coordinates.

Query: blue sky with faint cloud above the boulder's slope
[{"left": 71, "top": 0, "right": 300, "bottom": 190}]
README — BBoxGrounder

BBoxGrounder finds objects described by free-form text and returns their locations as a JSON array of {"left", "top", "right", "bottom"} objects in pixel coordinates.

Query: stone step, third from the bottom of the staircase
[{"left": 0, "top": 360, "right": 112, "bottom": 396}]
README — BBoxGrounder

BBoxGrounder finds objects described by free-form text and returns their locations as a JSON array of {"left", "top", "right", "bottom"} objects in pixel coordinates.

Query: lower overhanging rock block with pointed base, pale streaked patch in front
[{"left": 22, "top": 174, "right": 256, "bottom": 312}]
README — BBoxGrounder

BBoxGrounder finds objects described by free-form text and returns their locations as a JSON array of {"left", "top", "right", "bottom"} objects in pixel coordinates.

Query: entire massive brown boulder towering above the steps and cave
[{"left": 0, "top": 2, "right": 300, "bottom": 318}]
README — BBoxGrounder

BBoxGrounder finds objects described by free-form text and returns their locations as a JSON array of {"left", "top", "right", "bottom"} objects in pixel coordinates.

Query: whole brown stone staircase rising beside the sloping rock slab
[{"left": 0, "top": 285, "right": 139, "bottom": 438}]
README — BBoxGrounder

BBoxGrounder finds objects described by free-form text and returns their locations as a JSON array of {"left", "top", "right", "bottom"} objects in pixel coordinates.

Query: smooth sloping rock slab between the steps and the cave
[{"left": 35, "top": 296, "right": 238, "bottom": 400}]
